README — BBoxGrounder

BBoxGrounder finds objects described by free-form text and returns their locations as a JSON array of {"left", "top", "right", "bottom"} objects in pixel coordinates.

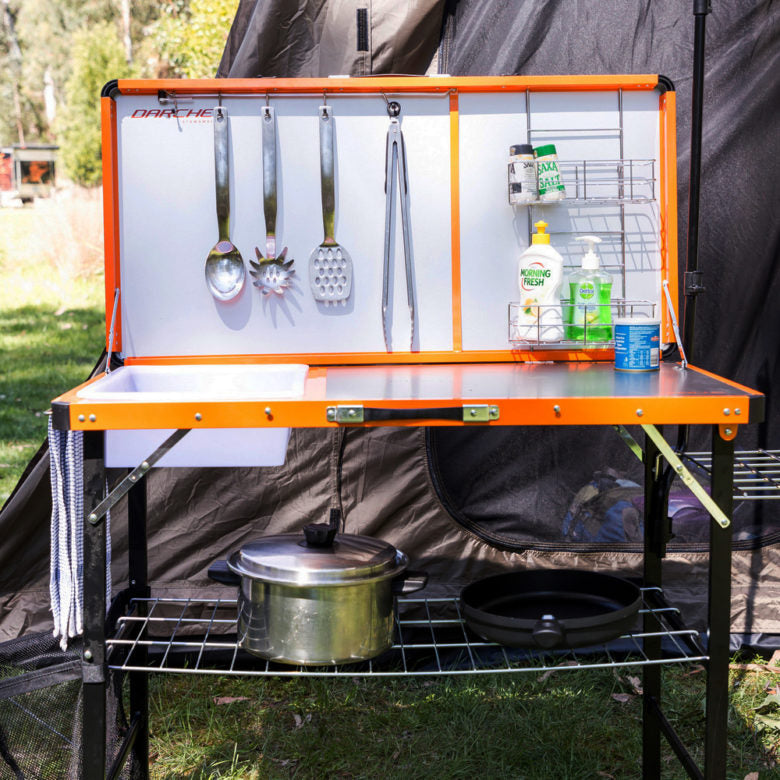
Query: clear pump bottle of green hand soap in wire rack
[{"left": 566, "top": 236, "right": 612, "bottom": 341}]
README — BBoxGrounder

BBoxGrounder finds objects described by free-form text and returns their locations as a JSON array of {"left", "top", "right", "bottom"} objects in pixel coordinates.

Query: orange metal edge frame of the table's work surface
[{"left": 54, "top": 363, "right": 759, "bottom": 435}]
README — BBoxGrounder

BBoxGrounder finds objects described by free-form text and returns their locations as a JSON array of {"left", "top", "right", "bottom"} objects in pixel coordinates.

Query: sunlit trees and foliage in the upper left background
[{"left": 0, "top": 0, "right": 238, "bottom": 185}]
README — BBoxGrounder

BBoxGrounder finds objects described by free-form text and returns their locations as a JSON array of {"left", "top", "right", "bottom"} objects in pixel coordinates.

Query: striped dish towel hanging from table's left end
[{"left": 49, "top": 418, "right": 111, "bottom": 650}]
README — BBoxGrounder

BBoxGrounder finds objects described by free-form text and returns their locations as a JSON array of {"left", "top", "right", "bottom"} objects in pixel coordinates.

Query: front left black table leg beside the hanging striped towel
[{"left": 81, "top": 432, "right": 106, "bottom": 780}]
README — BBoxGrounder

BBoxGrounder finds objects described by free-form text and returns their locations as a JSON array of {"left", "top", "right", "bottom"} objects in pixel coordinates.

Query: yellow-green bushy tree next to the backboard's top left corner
[{"left": 58, "top": 22, "right": 133, "bottom": 187}]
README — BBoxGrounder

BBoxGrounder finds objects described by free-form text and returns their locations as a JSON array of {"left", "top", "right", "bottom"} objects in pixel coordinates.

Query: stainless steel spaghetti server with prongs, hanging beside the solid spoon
[{"left": 249, "top": 106, "right": 295, "bottom": 295}]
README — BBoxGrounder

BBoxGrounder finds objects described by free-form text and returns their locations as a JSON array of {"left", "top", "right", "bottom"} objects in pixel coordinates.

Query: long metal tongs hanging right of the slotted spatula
[{"left": 382, "top": 100, "right": 414, "bottom": 352}]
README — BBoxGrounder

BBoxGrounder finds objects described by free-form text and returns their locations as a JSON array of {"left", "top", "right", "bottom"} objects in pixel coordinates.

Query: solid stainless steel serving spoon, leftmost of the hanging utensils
[{"left": 206, "top": 106, "right": 246, "bottom": 301}]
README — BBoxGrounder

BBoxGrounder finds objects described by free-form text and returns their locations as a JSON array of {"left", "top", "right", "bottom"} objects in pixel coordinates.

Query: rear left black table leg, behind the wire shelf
[{"left": 127, "top": 479, "right": 150, "bottom": 780}]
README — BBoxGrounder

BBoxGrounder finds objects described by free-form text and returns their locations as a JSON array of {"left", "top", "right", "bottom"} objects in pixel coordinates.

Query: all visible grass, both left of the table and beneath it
[{"left": 0, "top": 203, "right": 780, "bottom": 780}]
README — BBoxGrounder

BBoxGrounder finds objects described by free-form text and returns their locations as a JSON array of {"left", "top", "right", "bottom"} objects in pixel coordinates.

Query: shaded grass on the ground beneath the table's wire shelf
[{"left": 151, "top": 666, "right": 780, "bottom": 780}]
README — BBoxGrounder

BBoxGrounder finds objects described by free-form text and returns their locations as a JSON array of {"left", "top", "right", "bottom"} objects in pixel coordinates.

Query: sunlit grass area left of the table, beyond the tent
[{"left": 0, "top": 203, "right": 104, "bottom": 505}]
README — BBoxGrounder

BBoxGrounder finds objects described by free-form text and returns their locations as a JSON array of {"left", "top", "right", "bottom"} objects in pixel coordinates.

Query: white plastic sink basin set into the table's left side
[{"left": 78, "top": 364, "right": 309, "bottom": 468}]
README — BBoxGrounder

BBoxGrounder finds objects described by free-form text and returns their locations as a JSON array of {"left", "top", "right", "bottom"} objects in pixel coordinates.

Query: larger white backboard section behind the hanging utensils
[{"left": 118, "top": 96, "right": 452, "bottom": 356}]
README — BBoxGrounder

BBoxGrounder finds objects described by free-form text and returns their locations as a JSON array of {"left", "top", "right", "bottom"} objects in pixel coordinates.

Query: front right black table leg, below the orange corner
[{"left": 704, "top": 425, "right": 734, "bottom": 779}]
